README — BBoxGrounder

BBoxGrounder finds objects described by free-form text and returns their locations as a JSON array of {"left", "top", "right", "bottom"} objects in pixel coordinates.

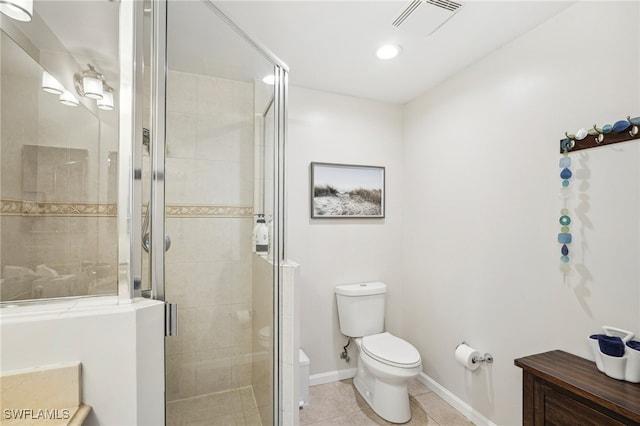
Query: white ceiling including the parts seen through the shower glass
[{"left": 27, "top": 0, "right": 574, "bottom": 103}]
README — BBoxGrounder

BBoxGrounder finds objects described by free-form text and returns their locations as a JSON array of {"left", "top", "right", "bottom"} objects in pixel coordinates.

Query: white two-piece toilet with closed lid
[{"left": 335, "top": 282, "right": 422, "bottom": 423}]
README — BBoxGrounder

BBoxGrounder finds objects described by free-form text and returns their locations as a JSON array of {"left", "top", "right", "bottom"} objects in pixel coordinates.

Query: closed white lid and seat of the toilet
[{"left": 362, "top": 332, "right": 422, "bottom": 368}]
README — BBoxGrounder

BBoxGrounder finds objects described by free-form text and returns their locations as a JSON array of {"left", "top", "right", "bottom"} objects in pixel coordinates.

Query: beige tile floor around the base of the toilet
[{"left": 300, "top": 379, "right": 473, "bottom": 426}]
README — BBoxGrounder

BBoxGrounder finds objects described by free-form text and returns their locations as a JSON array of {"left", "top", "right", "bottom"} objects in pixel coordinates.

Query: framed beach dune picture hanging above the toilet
[{"left": 311, "top": 163, "right": 385, "bottom": 219}]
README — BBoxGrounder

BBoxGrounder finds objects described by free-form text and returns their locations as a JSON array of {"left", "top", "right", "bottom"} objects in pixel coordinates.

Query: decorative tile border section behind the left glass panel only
[{"left": 0, "top": 199, "right": 117, "bottom": 217}]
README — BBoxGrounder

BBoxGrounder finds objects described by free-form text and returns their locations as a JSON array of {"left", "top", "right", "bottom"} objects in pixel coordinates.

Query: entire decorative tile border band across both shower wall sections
[{"left": 0, "top": 199, "right": 253, "bottom": 218}]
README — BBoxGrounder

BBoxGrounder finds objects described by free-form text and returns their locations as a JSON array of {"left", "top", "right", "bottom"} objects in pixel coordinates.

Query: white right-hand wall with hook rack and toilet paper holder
[{"left": 402, "top": 2, "right": 640, "bottom": 425}]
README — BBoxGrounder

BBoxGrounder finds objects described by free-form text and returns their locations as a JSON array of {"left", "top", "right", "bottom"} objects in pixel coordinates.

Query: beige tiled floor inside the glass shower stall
[{"left": 166, "top": 387, "right": 262, "bottom": 426}]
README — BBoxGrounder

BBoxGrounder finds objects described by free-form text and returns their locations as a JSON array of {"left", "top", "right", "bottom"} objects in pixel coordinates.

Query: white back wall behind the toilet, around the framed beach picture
[{"left": 286, "top": 87, "right": 404, "bottom": 374}]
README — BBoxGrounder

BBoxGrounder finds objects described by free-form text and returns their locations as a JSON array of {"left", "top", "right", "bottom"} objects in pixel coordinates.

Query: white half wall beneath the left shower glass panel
[{"left": 0, "top": 297, "right": 164, "bottom": 426}]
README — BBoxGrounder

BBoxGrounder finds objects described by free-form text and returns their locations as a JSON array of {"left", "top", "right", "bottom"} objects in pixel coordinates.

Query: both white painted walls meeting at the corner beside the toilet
[{"left": 287, "top": 2, "right": 640, "bottom": 425}]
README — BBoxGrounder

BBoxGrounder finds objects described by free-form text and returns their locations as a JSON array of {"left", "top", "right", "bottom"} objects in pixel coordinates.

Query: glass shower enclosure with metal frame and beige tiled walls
[{"left": 0, "top": 0, "right": 287, "bottom": 425}]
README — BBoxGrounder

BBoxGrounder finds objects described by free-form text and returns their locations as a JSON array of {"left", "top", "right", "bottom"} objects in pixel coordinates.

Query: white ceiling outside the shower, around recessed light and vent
[{"left": 215, "top": 0, "right": 574, "bottom": 103}]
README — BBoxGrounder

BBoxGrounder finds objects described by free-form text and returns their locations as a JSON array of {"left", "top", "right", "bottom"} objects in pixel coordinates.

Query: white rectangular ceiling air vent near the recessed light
[{"left": 392, "top": 0, "right": 462, "bottom": 36}]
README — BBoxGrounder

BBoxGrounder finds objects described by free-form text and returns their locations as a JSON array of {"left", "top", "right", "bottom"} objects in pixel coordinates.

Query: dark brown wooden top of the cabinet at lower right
[{"left": 514, "top": 350, "right": 640, "bottom": 424}]
